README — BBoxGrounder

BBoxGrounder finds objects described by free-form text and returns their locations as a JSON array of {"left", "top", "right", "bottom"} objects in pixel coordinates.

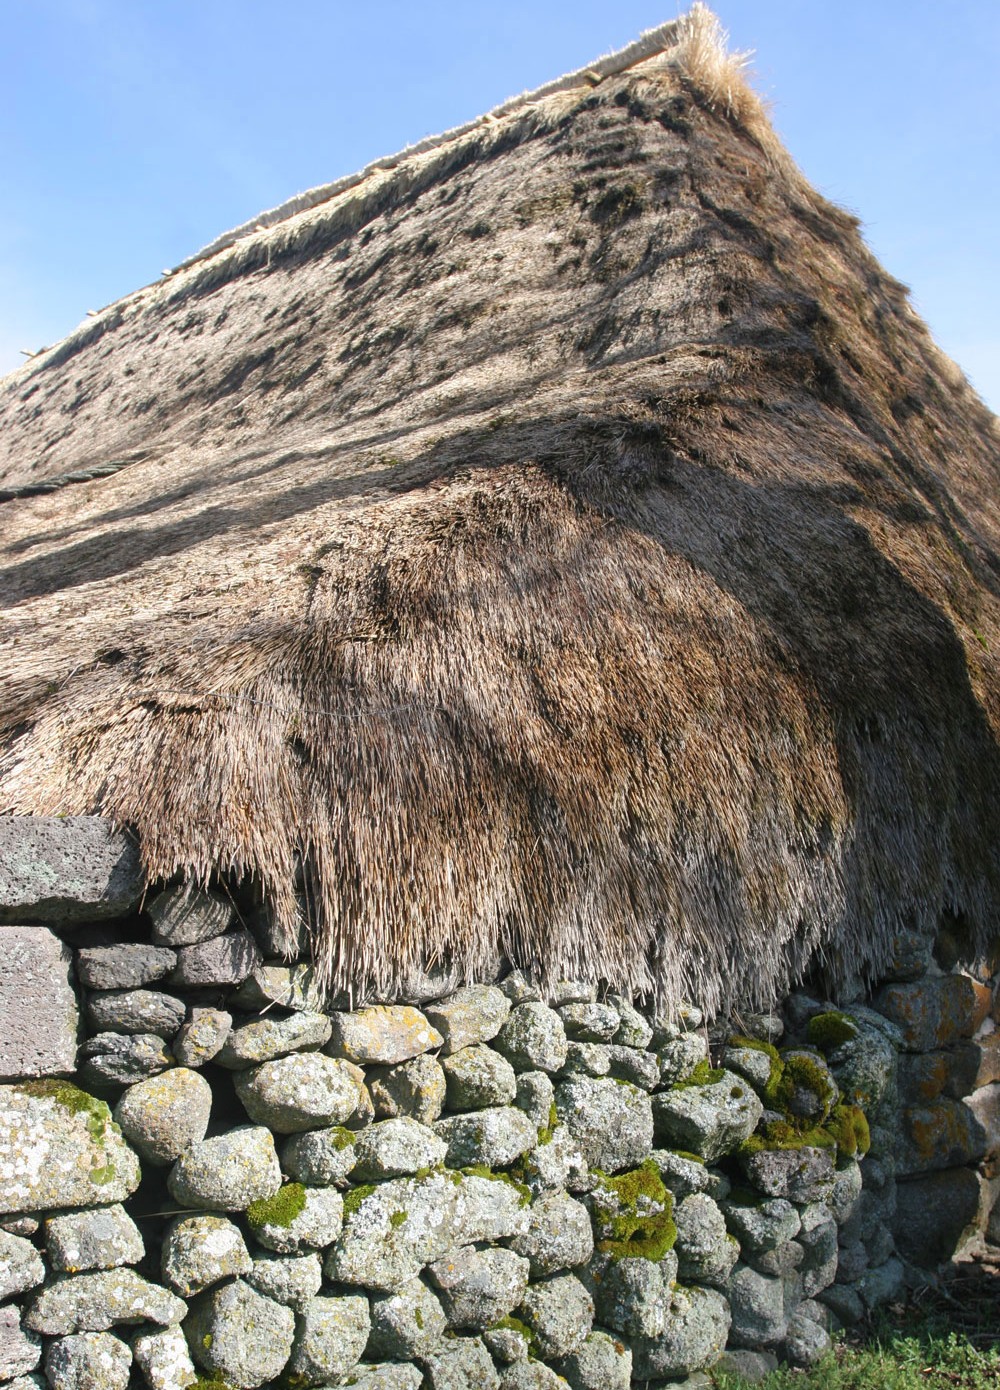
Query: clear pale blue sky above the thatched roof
[{"left": 0, "top": 0, "right": 1000, "bottom": 410}]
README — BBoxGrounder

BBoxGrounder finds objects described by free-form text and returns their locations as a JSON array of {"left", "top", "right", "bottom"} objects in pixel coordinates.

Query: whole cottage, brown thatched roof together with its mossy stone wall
[{"left": 0, "top": 6, "right": 1000, "bottom": 1390}]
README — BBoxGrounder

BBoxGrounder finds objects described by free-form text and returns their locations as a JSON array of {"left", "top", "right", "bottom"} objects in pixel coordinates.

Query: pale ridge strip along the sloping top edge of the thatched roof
[{"left": 172, "top": 17, "right": 684, "bottom": 275}]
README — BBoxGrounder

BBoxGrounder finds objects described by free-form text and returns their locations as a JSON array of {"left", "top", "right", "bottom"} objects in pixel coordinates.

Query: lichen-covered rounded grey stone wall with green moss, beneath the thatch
[{"left": 0, "top": 817, "right": 1000, "bottom": 1390}]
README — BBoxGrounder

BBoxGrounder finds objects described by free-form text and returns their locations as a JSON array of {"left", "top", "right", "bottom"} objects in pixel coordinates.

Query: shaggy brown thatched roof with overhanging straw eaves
[{"left": 0, "top": 8, "right": 1000, "bottom": 1006}]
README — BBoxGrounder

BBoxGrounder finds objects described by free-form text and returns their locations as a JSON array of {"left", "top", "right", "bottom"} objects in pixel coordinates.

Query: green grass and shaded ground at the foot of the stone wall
[{"left": 712, "top": 1270, "right": 1000, "bottom": 1390}]
